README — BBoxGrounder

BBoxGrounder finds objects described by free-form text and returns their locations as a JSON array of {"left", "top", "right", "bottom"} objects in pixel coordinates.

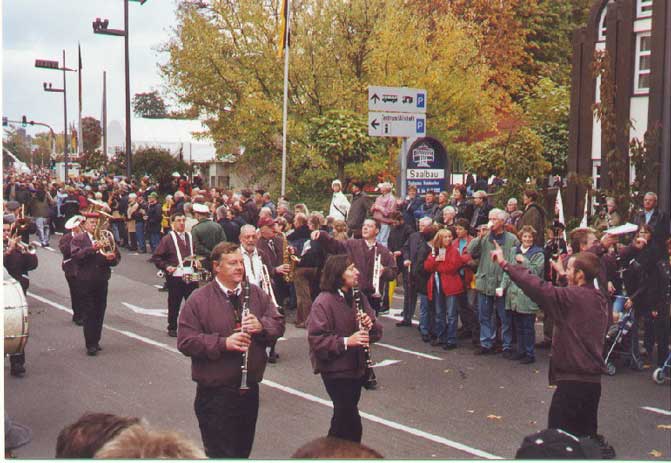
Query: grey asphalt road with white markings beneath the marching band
[{"left": 4, "top": 237, "right": 671, "bottom": 459}]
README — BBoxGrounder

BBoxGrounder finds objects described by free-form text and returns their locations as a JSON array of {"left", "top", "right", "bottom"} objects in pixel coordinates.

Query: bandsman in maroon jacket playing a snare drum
[{"left": 151, "top": 212, "right": 198, "bottom": 338}]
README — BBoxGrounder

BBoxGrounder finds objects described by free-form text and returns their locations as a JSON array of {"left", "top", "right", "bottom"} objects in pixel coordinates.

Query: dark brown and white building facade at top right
[{"left": 566, "top": 0, "right": 671, "bottom": 216}]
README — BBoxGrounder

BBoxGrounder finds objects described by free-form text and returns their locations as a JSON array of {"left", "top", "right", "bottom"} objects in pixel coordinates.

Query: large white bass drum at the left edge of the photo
[{"left": 2, "top": 275, "right": 28, "bottom": 355}]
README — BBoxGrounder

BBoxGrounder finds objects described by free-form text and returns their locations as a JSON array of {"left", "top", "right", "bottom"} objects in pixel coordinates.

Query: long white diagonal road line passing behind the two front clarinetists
[{"left": 28, "top": 294, "right": 503, "bottom": 460}]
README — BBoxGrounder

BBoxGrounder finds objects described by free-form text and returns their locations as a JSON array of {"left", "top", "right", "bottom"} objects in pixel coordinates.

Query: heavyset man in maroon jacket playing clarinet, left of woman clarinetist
[{"left": 177, "top": 242, "right": 284, "bottom": 458}]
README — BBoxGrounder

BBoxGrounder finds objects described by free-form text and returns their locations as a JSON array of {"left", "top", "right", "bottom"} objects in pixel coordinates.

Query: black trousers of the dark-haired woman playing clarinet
[{"left": 322, "top": 376, "right": 363, "bottom": 442}]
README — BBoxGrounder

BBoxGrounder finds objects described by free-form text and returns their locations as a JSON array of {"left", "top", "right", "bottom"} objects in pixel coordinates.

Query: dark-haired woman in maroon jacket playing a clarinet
[{"left": 307, "top": 256, "right": 382, "bottom": 442}]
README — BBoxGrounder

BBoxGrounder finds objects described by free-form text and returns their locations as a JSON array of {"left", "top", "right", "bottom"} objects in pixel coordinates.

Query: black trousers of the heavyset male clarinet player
[{"left": 194, "top": 384, "right": 259, "bottom": 458}]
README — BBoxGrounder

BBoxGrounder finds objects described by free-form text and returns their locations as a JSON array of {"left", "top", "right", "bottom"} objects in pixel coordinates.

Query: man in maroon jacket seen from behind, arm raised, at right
[{"left": 483, "top": 243, "right": 614, "bottom": 457}]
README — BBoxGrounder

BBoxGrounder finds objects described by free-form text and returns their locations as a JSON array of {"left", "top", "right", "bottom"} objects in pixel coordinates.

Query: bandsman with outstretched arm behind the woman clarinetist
[{"left": 311, "top": 219, "right": 397, "bottom": 313}]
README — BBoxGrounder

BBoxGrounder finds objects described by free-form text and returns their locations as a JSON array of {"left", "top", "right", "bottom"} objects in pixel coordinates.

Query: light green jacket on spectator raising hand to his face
[{"left": 468, "top": 232, "right": 520, "bottom": 296}]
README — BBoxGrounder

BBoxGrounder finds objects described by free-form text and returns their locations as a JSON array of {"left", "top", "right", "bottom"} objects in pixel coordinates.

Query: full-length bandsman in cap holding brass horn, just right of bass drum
[{"left": 70, "top": 212, "right": 121, "bottom": 356}]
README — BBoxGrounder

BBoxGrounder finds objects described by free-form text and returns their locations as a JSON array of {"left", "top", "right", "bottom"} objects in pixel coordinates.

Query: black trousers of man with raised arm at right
[{"left": 548, "top": 381, "right": 601, "bottom": 437}]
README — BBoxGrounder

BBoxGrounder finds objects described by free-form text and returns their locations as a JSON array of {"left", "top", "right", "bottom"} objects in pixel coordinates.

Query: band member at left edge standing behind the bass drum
[{"left": 2, "top": 215, "right": 37, "bottom": 376}]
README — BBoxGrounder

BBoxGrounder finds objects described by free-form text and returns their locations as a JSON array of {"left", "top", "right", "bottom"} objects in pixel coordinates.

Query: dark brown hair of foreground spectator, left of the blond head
[{"left": 56, "top": 413, "right": 140, "bottom": 458}]
